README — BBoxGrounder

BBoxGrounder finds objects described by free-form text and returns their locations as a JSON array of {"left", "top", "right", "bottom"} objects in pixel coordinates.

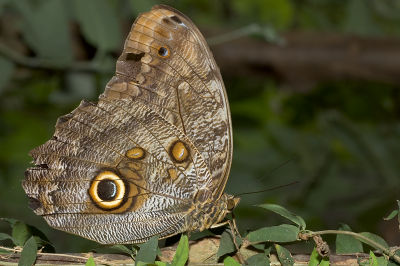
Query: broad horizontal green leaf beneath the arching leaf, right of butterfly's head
[{"left": 247, "top": 224, "right": 300, "bottom": 242}]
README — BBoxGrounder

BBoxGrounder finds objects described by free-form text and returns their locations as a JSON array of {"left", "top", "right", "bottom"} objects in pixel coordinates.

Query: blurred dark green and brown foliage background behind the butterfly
[{"left": 0, "top": 0, "right": 400, "bottom": 252}]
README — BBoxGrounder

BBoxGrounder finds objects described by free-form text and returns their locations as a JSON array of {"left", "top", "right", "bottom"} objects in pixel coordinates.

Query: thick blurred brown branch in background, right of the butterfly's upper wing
[{"left": 212, "top": 32, "right": 400, "bottom": 89}]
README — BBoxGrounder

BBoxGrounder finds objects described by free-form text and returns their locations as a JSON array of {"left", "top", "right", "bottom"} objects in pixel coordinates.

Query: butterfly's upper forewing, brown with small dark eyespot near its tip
[{"left": 109, "top": 6, "right": 232, "bottom": 197}]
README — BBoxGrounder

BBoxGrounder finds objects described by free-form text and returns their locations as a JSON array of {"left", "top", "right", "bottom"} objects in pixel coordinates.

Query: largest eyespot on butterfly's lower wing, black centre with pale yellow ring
[{"left": 89, "top": 171, "right": 126, "bottom": 210}]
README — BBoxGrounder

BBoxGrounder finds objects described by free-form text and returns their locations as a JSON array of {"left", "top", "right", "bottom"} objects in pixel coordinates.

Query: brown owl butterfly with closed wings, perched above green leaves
[{"left": 22, "top": 6, "right": 239, "bottom": 244}]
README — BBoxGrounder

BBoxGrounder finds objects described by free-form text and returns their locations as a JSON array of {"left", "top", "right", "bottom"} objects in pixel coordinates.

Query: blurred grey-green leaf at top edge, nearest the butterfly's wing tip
[{"left": 72, "top": 0, "right": 122, "bottom": 51}]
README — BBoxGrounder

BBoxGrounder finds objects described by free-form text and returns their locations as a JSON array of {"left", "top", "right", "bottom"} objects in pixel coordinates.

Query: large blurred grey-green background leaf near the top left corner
[{"left": 12, "top": 0, "right": 72, "bottom": 62}]
